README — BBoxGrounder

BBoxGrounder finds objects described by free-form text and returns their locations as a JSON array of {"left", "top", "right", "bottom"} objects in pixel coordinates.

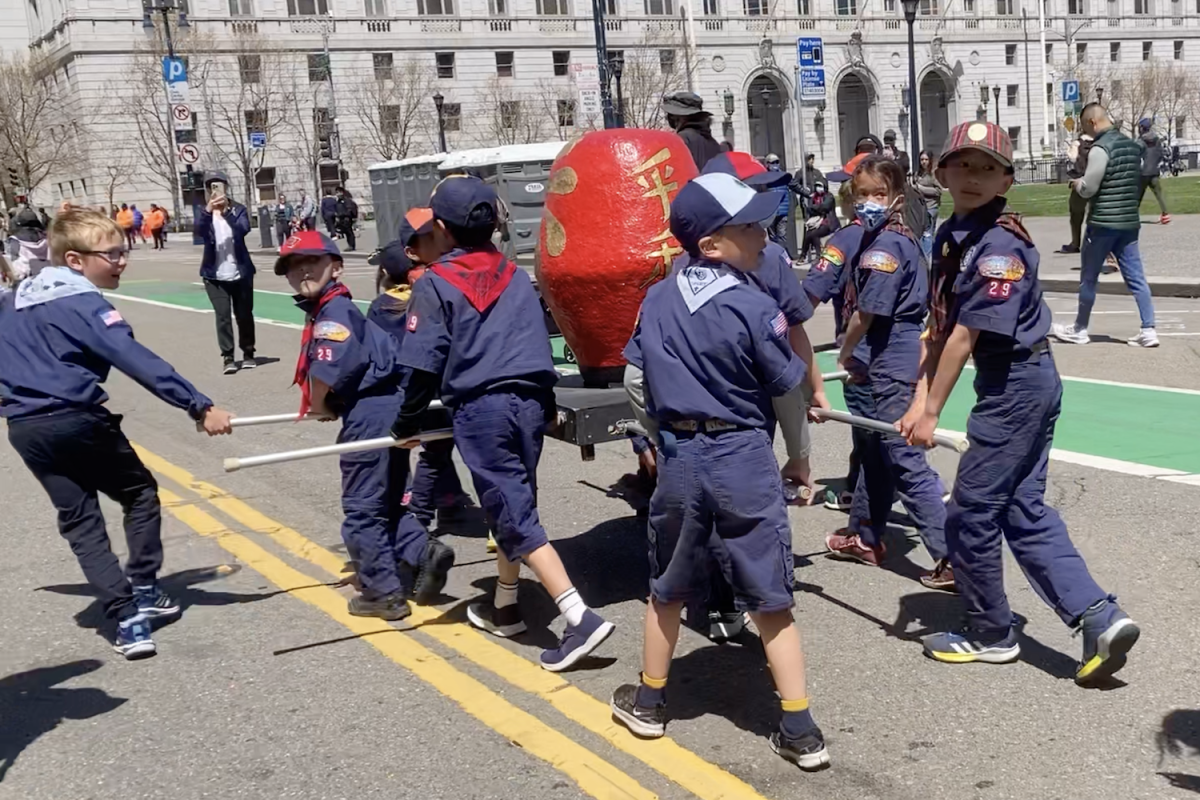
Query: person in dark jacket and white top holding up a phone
[{"left": 196, "top": 172, "right": 258, "bottom": 375}]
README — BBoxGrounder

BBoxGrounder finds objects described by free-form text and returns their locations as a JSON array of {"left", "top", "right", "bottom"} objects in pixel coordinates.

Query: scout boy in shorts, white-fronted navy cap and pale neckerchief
[{"left": 612, "top": 174, "right": 829, "bottom": 769}]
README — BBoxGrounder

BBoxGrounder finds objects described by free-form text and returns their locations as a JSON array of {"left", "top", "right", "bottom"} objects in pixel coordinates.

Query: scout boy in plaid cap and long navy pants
[{"left": 896, "top": 122, "right": 1140, "bottom": 685}]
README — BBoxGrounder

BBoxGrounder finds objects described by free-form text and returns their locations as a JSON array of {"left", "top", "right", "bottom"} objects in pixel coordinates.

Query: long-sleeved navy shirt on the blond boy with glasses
[{"left": 0, "top": 284, "right": 212, "bottom": 420}]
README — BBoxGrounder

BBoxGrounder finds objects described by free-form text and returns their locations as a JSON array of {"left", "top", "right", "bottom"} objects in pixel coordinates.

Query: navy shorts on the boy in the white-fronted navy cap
[{"left": 649, "top": 429, "right": 794, "bottom": 612}]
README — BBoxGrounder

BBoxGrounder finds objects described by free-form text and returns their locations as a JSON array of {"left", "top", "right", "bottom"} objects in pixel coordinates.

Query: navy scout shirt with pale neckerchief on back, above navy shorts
[{"left": 625, "top": 261, "right": 804, "bottom": 428}]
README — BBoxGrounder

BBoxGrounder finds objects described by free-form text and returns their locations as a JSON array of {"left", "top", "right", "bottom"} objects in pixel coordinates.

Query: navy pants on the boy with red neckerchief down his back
[{"left": 454, "top": 391, "right": 554, "bottom": 561}]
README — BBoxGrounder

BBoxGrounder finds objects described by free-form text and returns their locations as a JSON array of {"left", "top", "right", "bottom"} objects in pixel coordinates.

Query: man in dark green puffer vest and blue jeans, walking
[{"left": 1051, "top": 103, "right": 1158, "bottom": 347}]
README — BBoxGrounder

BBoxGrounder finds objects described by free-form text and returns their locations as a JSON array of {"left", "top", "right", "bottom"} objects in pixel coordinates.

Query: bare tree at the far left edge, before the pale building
[{"left": 0, "top": 56, "right": 88, "bottom": 193}]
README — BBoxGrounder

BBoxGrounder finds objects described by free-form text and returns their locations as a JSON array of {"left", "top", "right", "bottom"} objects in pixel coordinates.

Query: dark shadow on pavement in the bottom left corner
[{"left": 0, "top": 658, "right": 126, "bottom": 782}]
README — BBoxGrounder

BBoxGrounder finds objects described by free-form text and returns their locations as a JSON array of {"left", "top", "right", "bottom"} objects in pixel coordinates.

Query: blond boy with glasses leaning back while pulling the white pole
[{"left": 0, "top": 209, "right": 232, "bottom": 660}]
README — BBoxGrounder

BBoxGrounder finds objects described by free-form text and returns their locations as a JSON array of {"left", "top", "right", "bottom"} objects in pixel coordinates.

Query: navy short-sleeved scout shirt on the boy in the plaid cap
[{"left": 934, "top": 209, "right": 1052, "bottom": 366}]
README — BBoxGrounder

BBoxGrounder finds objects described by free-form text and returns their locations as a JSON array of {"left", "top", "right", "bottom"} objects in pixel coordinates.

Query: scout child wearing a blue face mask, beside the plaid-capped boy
[{"left": 826, "top": 156, "right": 954, "bottom": 589}]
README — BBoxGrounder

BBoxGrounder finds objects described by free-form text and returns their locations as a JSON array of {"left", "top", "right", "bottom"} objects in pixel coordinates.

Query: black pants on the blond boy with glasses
[{"left": 8, "top": 407, "right": 162, "bottom": 620}]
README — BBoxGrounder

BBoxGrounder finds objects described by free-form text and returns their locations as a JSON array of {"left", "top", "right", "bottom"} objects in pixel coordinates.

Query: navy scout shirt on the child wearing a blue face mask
[{"left": 852, "top": 230, "right": 929, "bottom": 383}]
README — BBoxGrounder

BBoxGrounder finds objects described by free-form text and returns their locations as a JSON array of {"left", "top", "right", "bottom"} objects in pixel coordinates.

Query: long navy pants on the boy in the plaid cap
[{"left": 946, "top": 351, "right": 1108, "bottom": 631}]
